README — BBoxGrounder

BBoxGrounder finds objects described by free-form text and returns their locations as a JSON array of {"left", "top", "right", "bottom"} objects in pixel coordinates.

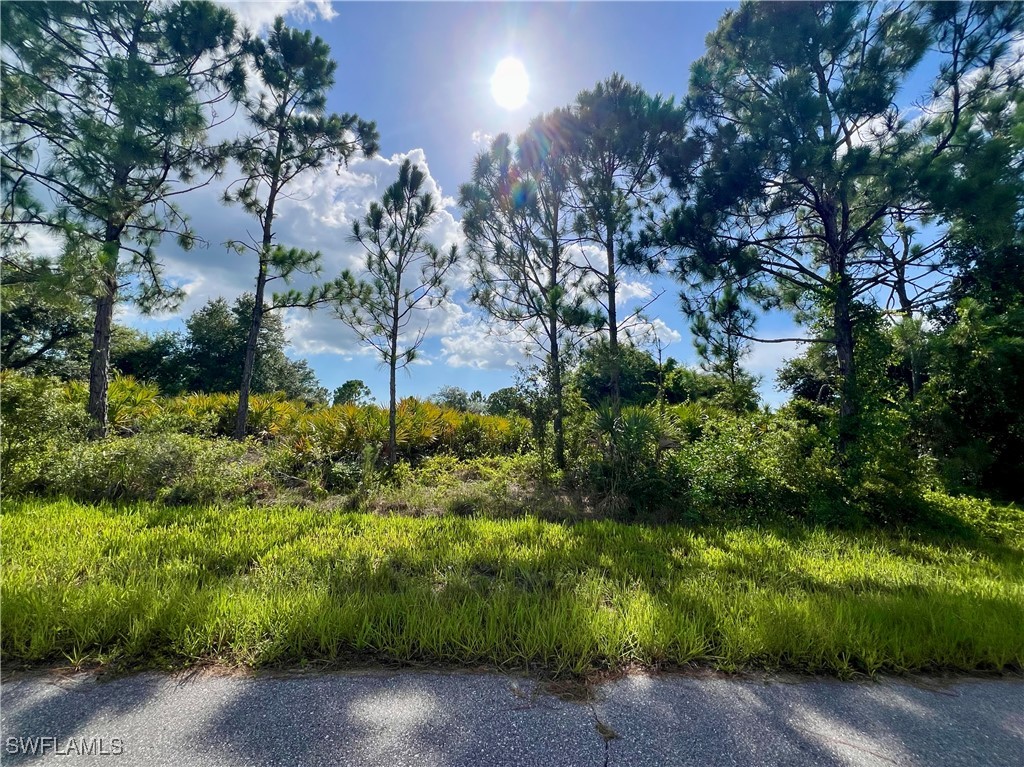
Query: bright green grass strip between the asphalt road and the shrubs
[{"left": 2, "top": 500, "right": 1024, "bottom": 675}]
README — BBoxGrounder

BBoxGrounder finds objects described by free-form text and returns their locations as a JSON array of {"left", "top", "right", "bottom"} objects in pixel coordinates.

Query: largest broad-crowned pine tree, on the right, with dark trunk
[{"left": 660, "top": 2, "right": 1022, "bottom": 454}]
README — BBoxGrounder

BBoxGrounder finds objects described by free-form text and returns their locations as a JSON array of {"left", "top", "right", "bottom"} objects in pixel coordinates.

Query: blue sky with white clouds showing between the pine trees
[{"left": 121, "top": 0, "right": 800, "bottom": 403}]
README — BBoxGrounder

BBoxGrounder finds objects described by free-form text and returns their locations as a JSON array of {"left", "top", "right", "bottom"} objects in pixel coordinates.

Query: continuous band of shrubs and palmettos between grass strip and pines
[{"left": 0, "top": 373, "right": 939, "bottom": 524}]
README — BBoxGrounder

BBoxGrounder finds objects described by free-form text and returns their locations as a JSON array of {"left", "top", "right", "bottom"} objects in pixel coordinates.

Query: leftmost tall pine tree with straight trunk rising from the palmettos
[{"left": 0, "top": 1, "right": 245, "bottom": 435}]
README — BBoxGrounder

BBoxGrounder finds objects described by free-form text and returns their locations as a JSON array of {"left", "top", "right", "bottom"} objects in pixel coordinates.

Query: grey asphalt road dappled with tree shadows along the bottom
[{"left": 0, "top": 671, "right": 1024, "bottom": 767}]
